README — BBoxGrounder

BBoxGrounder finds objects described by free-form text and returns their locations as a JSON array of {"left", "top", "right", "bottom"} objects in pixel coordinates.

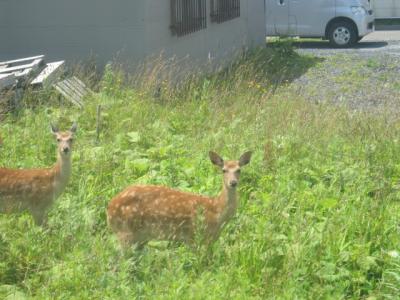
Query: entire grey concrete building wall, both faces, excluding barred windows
[{"left": 0, "top": 0, "right": 265, "bottom": 65}]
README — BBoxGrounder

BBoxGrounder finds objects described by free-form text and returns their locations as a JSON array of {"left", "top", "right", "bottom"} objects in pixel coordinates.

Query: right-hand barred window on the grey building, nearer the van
[{"left": 211, "top": 0, "right": 240, "bottom": 23}]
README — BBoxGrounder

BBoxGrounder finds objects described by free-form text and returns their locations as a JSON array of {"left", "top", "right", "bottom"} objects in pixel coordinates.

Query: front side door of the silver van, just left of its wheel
[{"left": 286, "top": 0, "right": 336, "bottom": 37}]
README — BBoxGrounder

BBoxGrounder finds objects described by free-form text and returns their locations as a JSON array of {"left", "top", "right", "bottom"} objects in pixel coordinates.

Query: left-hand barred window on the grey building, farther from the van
[{"left": 171, "top": 0, "right": 207, "bottom": 36}]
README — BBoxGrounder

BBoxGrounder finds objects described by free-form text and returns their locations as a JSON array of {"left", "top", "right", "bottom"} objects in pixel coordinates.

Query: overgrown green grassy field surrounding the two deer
[{"left": 0, "top": 44, "right": 400, "bottom": 299}]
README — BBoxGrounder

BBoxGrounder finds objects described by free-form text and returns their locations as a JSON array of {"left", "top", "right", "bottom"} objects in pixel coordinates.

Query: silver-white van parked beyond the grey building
[{"left": 265, "top": 0, "right": 374, "bottom": 47}]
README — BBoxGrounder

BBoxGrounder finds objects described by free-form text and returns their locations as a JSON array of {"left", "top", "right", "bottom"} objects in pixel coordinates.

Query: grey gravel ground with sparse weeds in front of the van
[{"left": 290, "top": 32, "right": 400, "bottom": 112}]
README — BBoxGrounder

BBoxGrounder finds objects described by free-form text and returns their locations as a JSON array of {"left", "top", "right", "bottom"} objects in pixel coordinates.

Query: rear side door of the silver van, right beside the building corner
[{"left": 266, "top": 0, "right": 289, "bottom": 36}]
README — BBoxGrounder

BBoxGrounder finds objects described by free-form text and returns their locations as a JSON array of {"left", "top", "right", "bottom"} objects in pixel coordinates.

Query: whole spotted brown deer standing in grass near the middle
[{"left": 107, "top": 151, "right": 252, "bottom": 249}]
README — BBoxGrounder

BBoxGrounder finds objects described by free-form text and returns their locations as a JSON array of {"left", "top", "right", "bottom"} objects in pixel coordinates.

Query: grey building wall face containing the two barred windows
[{"left": 145, "top": 0, "right": 265, "bottom": 67}]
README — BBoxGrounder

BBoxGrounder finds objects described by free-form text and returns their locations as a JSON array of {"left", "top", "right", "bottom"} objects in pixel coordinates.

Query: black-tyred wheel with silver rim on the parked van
[{"left": 328, "top": 21, "right": 358, "bottom": 48}]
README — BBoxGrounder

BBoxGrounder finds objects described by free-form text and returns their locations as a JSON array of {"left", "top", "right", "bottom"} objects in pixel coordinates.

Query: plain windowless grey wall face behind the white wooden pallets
[{"left": 0, "top": 0, "right": 145, "bottom": 63}]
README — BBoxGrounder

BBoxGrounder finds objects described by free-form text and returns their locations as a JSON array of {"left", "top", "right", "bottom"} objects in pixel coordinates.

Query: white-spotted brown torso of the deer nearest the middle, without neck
[{"left": 108, "top": 186, "right": 222, "bottom": 241}]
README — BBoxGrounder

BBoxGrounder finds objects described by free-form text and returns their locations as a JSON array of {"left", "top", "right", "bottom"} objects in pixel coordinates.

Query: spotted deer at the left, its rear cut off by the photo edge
[{"left": 0, "top": 122, "right": 77, "bottom": 226}]
